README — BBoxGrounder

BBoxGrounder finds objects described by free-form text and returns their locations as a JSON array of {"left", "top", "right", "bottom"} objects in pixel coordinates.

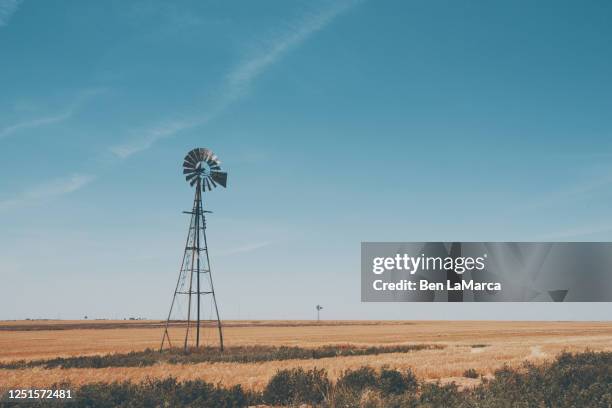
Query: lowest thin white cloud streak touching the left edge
[{"left": 0, "top": 174, "right": 95, "bottom": 210}]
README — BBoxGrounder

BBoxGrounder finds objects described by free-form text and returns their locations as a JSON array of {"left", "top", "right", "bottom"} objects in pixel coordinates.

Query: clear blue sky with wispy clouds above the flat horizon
[{"left": 0, "top": 0, "right": 612, "bottom": 319}]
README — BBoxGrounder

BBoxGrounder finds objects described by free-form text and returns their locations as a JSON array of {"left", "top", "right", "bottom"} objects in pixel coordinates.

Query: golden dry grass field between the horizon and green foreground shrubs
[{"left": 0, "top": 321, "right": 612, "bottom": 390}]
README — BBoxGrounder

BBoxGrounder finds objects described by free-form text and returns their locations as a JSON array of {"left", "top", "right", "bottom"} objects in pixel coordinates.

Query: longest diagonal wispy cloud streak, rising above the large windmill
[{"left": 110, "top": 0, "right": 357, "bottom": 159}]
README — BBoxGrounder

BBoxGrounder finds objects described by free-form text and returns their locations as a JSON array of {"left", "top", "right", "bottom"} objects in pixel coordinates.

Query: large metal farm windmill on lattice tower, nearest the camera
[{"left": 160, "top": 148, "right": 227, "bottom": 352}]
